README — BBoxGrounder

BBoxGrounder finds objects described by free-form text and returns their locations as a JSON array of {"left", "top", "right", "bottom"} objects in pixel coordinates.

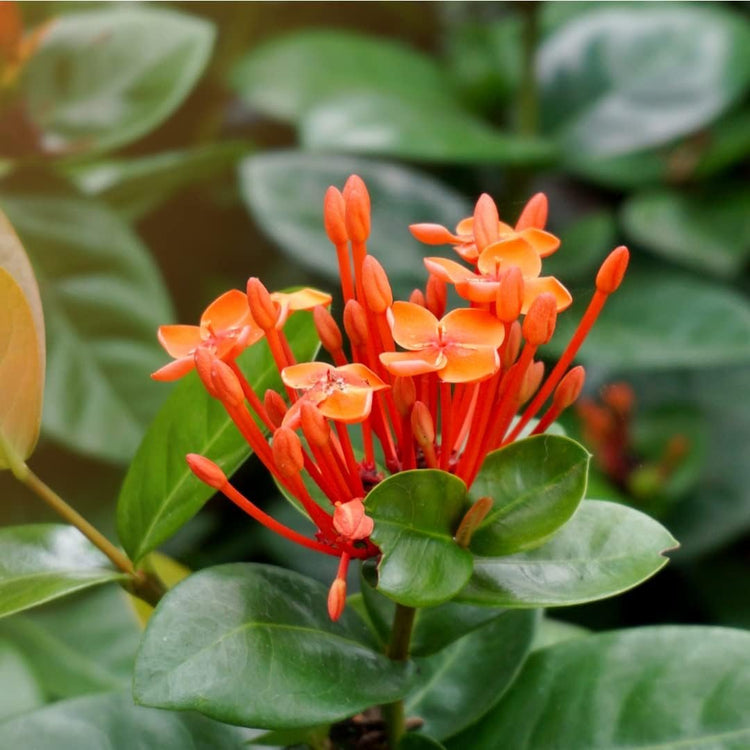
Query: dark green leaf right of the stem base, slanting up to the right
[{"left": 405, "top": 611, "right": 538, "bottom": 740}]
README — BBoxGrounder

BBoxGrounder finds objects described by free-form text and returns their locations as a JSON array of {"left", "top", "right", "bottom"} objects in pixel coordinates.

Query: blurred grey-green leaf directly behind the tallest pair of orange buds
[{"left": 240, "top": 151, "right": 471, "bottom": 296}]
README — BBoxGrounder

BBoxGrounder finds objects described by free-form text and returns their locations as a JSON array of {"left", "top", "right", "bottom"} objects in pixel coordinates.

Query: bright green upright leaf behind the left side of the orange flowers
[{"left": 117, "top": 313, "right": 318, "bottom": 562}]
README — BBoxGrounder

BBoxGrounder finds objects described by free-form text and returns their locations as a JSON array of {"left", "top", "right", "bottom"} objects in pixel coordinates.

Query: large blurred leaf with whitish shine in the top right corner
[{"left": 538, "top": 5, "right": 750, "bottom": 162}]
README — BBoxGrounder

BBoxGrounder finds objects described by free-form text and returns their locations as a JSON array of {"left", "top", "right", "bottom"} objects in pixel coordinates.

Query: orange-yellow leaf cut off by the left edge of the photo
[{"left": 0, "top": 268, "right": 44, "bottom": 473}]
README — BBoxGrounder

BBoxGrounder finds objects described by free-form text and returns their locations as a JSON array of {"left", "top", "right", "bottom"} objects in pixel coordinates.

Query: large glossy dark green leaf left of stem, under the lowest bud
[{"left": 134, "top": 564, "right": 412, "bottom": 729}]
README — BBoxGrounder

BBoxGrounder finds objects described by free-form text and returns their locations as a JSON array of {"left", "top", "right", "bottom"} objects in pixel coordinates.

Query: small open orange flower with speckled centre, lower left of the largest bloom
[{"left": 281, "top": 362, "right": 388, "bottom": 428}]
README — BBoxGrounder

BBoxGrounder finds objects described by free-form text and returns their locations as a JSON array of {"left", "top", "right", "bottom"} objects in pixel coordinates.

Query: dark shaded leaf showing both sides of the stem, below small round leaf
[{"left": 360, "top": 566, "right": 503, "bottom": 656}]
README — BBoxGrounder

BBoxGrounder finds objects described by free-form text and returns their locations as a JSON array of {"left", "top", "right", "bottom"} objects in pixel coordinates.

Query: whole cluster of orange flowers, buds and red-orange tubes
[{"left": 154, "top": 176, "right": 628, "bottom": 619}]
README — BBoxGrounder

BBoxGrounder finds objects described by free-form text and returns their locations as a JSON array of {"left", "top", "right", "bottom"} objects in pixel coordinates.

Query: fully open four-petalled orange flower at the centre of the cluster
[{"left": 380, "top": 302, "right": 505, "bottom": 383}]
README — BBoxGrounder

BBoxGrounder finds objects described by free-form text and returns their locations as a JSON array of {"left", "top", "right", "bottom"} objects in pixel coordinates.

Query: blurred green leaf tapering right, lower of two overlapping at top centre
[{"left": 300, "top": 92, "right": 556, "bottom": 165}]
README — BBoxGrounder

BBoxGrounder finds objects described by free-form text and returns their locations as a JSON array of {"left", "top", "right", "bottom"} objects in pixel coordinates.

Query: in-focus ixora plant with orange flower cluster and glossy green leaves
[{"left": 0, "top": 176, "right": 750, "bottom": 750}]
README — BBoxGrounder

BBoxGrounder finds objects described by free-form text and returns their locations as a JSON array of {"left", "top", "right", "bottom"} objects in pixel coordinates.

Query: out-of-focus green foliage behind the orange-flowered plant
[{"left": 0, "top": 2, "right": 750, "bottom": 713}]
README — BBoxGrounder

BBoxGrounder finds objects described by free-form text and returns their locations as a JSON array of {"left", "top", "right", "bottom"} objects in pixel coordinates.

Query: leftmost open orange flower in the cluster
[{"left": 151, "top": 289, "right": 263, "bottom": 381}]
